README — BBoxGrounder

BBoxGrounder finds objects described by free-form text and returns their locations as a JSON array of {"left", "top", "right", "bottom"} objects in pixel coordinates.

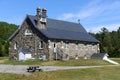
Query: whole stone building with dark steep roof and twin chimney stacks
[{"left": 9, "top": 8, "right": 100, "bottom": 60}]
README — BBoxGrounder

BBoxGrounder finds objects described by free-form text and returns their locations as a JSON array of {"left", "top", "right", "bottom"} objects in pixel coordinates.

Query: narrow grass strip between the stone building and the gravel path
[{"left": 0, "top": 58, "right": 110, "bottom": 66}]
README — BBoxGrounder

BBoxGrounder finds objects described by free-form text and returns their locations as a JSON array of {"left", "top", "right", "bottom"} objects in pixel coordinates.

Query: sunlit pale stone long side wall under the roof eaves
[{"left": 49, "top": 40, "right": 99, "bottom": 59}]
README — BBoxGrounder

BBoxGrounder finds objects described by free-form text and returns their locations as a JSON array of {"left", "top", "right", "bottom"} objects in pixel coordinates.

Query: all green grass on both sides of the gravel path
[{"left": 0, "top": 57, "right": 120, "bottom": 80}]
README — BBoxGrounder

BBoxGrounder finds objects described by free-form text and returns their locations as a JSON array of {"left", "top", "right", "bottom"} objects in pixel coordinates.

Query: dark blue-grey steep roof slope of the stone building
[{"left": 28, "top": 15, "right": 99, "bottom": 43}]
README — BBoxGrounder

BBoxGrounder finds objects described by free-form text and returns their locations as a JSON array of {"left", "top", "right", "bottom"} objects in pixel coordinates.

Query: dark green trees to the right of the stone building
[{"left": 91, "top": 27, "right": 120, "bottom": 57}]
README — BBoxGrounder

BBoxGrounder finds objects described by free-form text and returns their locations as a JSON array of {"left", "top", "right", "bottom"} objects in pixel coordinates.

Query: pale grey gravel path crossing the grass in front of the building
[{"left": 0, "top": 64, "right": 118, "bottom": 74}]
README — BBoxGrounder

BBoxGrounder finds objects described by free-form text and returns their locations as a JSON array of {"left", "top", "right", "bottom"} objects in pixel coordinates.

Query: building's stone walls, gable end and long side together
[{"left": 9, "top": 19, "right": 99, "bottom": 59}]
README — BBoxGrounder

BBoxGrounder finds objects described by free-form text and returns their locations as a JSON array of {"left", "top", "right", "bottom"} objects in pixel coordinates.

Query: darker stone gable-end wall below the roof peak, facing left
[{"left": 9, "top": 19, "right": 49, "bottom": 58}]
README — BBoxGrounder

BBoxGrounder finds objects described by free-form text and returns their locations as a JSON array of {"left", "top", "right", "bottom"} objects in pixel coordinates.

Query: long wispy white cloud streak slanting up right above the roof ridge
[{"left": 58, "top": 0, "right": 103, "bottom": 20}]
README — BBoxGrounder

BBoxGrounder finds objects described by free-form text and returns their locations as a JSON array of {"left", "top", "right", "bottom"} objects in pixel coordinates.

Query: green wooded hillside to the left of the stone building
[{"left": 0, "top": 22, "right": 18, "bottom": 57}]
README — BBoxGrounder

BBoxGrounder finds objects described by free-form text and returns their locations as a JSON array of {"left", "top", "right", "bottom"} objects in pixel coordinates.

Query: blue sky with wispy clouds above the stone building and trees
[{"left": 0, "top": 0, "right": 120, "bottom": 32}]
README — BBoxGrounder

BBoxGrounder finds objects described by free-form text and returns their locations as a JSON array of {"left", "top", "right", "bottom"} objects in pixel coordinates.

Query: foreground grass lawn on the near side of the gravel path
[{"left": 0, "top": 66, "right": 120, "bottom": 80}]
